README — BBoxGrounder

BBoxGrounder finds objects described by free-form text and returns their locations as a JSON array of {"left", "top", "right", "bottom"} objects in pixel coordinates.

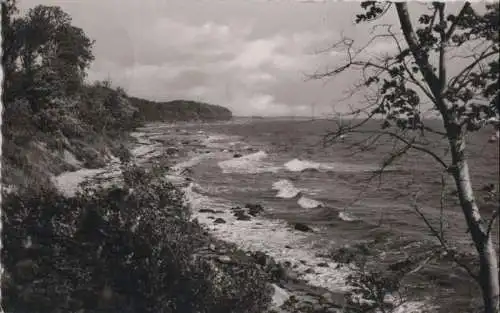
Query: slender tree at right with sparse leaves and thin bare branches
[{"left": 312, "top": 1, "right": 500, "bottom": 313}]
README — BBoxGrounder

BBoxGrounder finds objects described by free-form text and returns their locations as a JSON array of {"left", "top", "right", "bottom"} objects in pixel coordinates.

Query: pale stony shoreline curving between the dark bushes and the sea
[{"left": 52, "top": 123, "right": 432, "bottom": 313}]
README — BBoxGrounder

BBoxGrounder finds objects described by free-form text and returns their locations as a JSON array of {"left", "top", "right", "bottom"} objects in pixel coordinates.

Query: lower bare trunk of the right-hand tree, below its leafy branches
[{"left": 449, "top": 134, "right": 500, "bottom": 313}]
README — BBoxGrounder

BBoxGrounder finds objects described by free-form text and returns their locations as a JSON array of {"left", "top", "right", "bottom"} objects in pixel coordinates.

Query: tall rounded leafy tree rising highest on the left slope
[{"left": 8, "top": 5, "right": 94, "bottom": 112}]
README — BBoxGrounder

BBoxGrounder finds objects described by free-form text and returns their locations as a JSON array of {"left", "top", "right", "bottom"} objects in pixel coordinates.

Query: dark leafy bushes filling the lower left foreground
[{"left": 2, "top": 167, "right": 270, "bottom": 313}]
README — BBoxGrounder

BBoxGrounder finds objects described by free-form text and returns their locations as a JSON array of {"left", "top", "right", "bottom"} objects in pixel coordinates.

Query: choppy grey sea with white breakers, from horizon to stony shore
[{"left": 135, "top": 118, "right": 499, "bottom": 313}]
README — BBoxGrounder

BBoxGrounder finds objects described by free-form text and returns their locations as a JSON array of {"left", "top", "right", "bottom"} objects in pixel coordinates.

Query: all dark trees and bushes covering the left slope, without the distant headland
[{"left": 2, "top": 0, "right": 270, "bottom": 313}]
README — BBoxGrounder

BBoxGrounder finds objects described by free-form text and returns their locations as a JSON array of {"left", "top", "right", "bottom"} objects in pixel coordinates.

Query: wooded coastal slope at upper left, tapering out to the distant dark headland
[{"left": 2, "top": 1, "right": 231, "bottom": 188}]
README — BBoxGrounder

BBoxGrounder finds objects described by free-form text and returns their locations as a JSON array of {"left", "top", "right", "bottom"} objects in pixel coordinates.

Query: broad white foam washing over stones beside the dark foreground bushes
[{"left": 184, "top": 184, "right": 351, "bottom": 291}]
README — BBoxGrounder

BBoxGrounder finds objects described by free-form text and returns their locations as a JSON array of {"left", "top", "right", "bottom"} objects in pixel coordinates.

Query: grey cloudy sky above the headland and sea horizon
[{"left": 19, "top": 0, "right": 472, "bottom": 115}]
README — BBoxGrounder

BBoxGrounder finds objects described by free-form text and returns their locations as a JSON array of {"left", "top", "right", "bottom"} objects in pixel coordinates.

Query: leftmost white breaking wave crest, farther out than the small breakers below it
[{"left": 218, "top": 151, "right": 279, "bottom": 174}]
